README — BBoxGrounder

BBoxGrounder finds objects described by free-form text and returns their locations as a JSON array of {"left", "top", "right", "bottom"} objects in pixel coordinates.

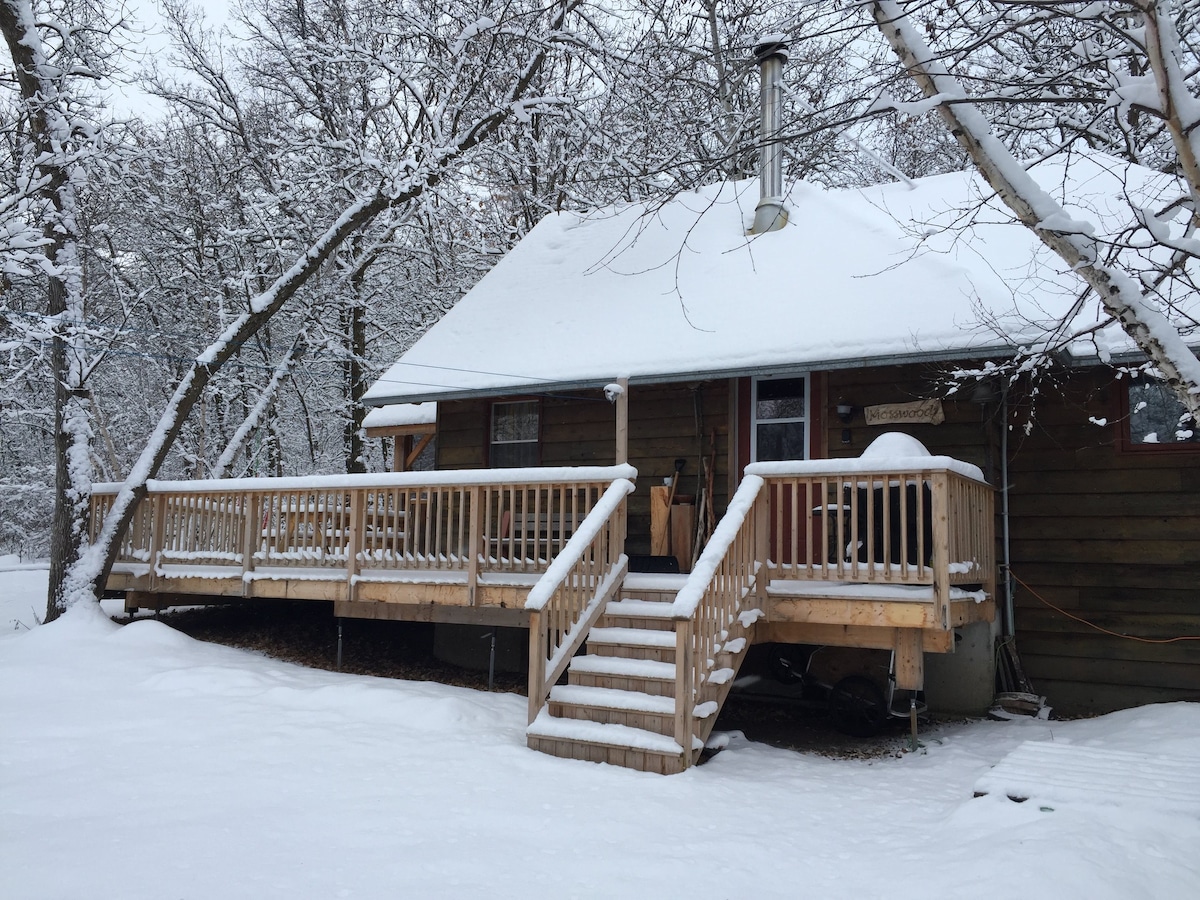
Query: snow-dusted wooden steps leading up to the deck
[{"left": 527, "top": 585, "right": 749, "bottom": 775}]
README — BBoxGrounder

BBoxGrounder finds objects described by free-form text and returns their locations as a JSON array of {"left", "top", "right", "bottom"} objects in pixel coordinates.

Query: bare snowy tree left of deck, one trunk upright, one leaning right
[{"left": 9, "top": 0, "right": 624, "bottom": 618}]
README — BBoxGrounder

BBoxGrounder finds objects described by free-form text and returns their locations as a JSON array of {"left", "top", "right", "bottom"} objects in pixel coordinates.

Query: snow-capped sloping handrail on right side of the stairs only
[{"left": 672, "top": 475, "right": 767, "bottom": 767}]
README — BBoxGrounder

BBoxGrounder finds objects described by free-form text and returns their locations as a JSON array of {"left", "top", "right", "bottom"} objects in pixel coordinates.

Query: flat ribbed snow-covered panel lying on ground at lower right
[{"left": 974, "top": 740, "right": 1200, "bottom": 815}]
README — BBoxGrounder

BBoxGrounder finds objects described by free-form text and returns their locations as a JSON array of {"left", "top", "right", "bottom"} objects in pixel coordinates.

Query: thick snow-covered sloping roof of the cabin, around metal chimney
[{"left": 366, "top": 155, "right": 1194, "bottom": 403}]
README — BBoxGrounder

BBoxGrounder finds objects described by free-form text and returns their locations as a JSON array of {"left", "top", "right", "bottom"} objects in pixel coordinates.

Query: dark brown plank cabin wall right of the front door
[{"left": 812, "top": 366, "right": 1200, "bottom": 713}]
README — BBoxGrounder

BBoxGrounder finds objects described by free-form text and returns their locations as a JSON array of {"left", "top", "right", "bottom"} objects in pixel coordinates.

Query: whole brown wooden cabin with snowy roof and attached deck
[{"left": 94, "top": 48, "right": 1200, "bottom": 773}]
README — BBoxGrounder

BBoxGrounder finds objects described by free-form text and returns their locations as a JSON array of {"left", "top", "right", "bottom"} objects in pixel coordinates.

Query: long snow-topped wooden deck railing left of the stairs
[{"left": 91, "top": 466, "right": 636, "bottom": 600}]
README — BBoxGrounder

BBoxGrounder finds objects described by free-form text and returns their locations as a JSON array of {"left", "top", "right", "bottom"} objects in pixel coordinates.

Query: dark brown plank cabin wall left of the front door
[{"left": 437, "top": 379, "right": 730, "bottom": 564}]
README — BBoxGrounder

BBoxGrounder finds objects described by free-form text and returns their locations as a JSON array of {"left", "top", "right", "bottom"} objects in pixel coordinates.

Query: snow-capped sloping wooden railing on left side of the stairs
[{"left": 526, "top": 479, "right": 634, "bottom": 722}]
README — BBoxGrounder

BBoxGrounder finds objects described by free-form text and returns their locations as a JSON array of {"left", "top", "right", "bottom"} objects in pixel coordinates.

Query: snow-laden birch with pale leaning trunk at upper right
[{"left": 871, "top": 0, "right": 1200, "bottom": 421}]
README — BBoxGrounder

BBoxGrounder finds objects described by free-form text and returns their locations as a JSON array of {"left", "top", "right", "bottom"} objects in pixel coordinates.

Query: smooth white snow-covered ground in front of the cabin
[{"left": 0, "top": 559, "right": 1200, "bottom": 900}]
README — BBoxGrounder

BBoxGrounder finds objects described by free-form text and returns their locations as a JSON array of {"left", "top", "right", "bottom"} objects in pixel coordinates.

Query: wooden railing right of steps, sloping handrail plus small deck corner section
[{"left": 674, "top": 457, "right": 995, "bottom": 760}]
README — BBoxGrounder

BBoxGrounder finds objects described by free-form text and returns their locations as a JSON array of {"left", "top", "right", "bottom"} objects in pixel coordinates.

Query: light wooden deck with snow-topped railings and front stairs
[{"left": 92, "top": 457, "right": 995, "bottom": 773}]
